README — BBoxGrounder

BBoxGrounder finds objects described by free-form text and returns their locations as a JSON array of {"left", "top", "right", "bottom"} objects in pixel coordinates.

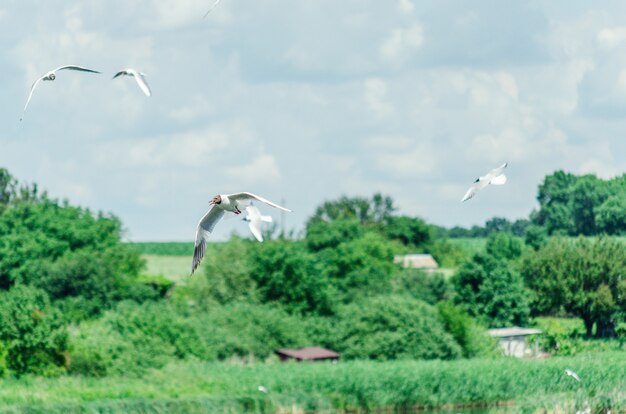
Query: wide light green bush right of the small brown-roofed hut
[{"left": 334, "top": 296, "right": 461, "bottom": 360}]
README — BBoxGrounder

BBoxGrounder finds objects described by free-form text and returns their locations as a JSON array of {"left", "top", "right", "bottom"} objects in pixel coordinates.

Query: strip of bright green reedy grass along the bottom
[{"left": 0, "top": 353, "right": 626, "bottom": 413}]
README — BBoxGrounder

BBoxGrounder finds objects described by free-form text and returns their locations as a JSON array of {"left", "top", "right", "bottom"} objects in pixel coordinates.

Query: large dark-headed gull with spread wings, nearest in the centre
[{"left": 191, "top": 192, "right": 291, "bottom": 274}]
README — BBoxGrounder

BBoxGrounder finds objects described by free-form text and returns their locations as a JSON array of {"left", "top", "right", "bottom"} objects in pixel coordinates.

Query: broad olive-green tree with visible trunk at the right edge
[{"left": 522, "top": 237, "right": 626, "bottom": 337}]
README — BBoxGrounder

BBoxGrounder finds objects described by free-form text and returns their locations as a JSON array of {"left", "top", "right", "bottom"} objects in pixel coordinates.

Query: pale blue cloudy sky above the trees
[{"left": 0, "top": 0, "right": 626, "bottom": 241}]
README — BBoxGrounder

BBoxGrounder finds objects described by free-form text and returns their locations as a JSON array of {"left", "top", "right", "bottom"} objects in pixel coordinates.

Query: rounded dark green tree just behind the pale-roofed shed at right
[{"left": 452, "top": 254, "right": 529, "bottom": 327}]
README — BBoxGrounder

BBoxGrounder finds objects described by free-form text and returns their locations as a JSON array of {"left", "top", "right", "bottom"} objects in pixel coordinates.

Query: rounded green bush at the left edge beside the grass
[{"left": 0, "top": 285, "right": 67, "bottom": 375}]
